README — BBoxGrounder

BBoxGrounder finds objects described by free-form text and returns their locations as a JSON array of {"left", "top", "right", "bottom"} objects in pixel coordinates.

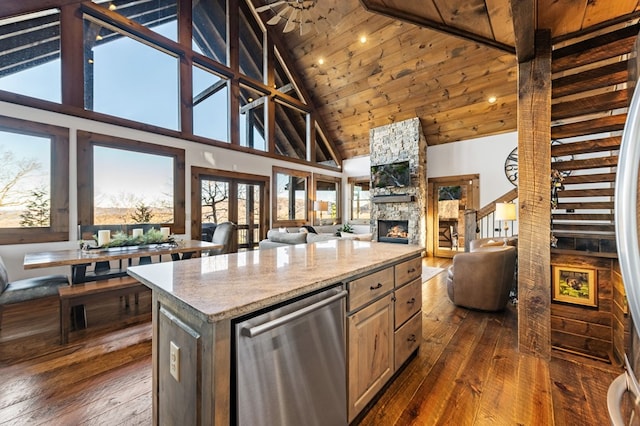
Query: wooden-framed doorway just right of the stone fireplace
[{"left": 427, "top": 174, "right": 480, "bottom": 257}]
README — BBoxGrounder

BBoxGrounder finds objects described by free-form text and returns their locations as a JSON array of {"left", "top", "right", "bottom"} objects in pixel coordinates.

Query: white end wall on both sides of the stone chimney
[{"left": 343, "top": 132, "right": 518, "bottom": 209}]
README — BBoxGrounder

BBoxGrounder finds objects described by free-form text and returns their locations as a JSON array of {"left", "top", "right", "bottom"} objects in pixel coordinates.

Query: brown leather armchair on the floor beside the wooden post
[{"left": 447, "top": 246, "right": 516, "bottom": 311}]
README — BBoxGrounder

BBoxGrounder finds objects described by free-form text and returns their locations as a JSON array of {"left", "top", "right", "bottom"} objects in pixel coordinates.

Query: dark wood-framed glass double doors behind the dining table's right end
[{"left": 191, "top": 167, "right": 269, "bottom": 251}]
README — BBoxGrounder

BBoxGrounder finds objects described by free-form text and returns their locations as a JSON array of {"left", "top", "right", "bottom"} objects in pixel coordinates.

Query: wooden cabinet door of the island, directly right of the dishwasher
[{"left": 347, "top": 293, "right": 395, "bottom": 422}]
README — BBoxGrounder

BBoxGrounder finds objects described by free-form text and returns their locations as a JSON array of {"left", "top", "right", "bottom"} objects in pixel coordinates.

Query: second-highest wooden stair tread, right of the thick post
[{"left": 551, "top": 60, "right": 628, "bottom": 99}]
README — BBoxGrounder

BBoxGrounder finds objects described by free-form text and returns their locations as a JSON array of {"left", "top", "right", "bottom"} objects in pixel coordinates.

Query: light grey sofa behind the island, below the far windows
[{"left": 258, "top": 225, "right": 372, "bottom": 250}]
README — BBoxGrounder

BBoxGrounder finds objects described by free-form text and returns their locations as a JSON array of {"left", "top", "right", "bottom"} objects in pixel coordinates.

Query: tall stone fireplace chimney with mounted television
[{"left": 369, "top": 118, "right": 427, "bottom": 247}]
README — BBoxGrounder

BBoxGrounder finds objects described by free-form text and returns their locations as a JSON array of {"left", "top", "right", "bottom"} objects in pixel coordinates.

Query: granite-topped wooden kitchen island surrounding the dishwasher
[{"left": 128, "top": 240, "right": 421, "bottom": 425}]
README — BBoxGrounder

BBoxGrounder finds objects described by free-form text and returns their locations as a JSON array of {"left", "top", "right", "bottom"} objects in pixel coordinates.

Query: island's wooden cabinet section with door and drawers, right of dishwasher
[{"left": 347, "top": 257, "right": 422, "bottom": 422}]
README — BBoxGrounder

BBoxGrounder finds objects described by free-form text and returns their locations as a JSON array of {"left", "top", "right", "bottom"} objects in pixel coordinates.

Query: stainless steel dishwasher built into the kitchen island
[{"left": 234, "top": 286, "right": 347, "bottom": 426}]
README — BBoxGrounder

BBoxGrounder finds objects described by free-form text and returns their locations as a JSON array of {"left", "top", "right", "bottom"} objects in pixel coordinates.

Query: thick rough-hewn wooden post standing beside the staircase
[{"left": 518, "top": 30, "right": 551, "bottom": 359}]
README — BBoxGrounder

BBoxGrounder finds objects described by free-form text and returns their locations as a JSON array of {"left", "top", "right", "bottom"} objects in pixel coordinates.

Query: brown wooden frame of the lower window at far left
[{"left": 0, "top": 116, "right": 69, "bottom": 245}]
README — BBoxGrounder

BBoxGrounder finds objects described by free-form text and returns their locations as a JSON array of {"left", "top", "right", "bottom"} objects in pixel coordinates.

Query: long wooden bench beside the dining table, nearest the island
[{"left": 58, "top": 276, "right": 148, "bottom": 345}]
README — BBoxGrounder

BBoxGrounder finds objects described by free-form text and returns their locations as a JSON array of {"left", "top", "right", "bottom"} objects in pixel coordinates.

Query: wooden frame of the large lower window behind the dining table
[{"left": 77, "top": 131, "right": 186, "bottom": 234}]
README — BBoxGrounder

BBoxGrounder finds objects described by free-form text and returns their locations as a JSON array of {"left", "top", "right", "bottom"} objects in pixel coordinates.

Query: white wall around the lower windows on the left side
[{"left": 0, "top": 102, "right": 342, "bottom": 280}]
